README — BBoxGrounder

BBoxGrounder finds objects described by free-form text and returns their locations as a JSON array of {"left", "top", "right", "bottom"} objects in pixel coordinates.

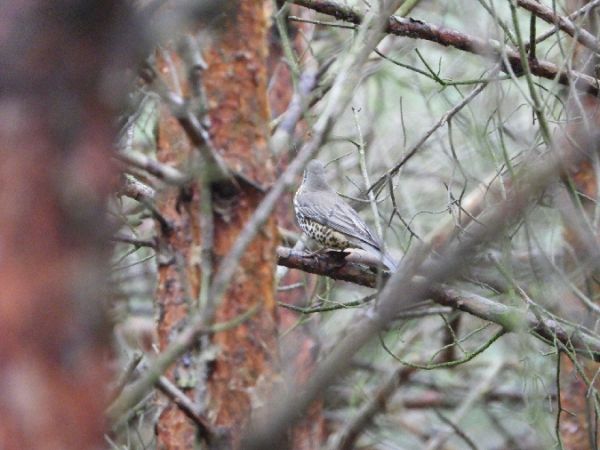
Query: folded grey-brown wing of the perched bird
[{"left": 296, "top": 192, "right": 381, "bottom": 250}]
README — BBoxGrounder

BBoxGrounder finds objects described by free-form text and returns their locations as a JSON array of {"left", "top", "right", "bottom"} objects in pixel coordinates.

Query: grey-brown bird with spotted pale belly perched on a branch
[{"left": 294, "top": 159, "right": 398, "bottom": 271}]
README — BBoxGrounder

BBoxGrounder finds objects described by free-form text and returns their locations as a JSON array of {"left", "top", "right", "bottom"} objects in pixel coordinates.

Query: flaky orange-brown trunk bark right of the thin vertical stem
[{"left": 203, "top": 0, "right": 278, "bottom": 448}]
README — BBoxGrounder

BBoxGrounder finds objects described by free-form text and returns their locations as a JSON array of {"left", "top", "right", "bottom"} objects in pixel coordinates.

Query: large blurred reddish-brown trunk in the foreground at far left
[{"left": 0, "top": 1, "right": 137, "bottom": 450}]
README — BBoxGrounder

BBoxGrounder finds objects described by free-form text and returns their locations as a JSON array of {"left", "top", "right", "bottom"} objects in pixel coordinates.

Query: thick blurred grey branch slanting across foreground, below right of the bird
[{"left": 245, "top": 130, "right": 600, "bottom": 449}]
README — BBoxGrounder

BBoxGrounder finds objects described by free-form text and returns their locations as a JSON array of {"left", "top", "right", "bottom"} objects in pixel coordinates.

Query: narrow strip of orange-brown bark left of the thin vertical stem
[{"left": 156, "top": 50, "right": 201, "bottom": 450}]
